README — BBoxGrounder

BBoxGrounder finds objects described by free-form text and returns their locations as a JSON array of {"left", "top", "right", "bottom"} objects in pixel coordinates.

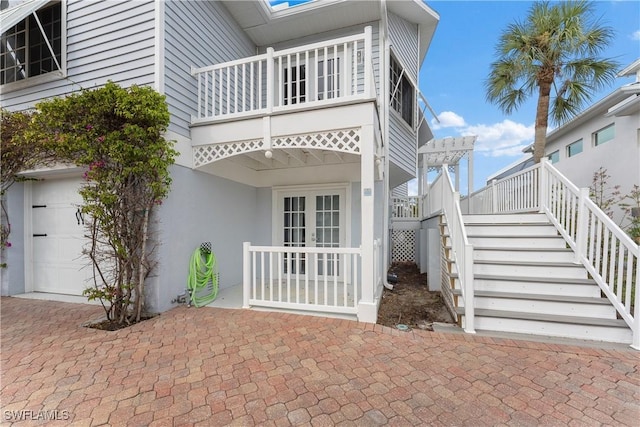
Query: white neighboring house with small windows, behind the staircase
[{"left": 487, "top": 59, "right": 640, "bottom": 224}]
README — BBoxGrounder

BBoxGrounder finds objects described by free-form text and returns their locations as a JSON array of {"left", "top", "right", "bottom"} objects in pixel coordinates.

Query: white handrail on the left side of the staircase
[{"left": 442, "top": 165, "right": 475, "bottom": 333}]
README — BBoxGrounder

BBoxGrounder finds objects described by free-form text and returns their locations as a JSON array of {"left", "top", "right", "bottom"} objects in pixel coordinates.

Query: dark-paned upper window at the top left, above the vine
[{"left": 0, "top": 3, "right": 63, "bottom": 84}]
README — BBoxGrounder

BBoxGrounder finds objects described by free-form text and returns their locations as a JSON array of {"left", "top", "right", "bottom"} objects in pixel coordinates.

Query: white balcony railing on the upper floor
[{"left": 192, "top": 27, "right": 375, "bottom": 123}]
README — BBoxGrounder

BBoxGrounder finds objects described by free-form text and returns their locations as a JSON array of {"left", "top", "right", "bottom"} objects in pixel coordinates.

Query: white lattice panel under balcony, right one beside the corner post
[{"left": 272, "top": 129, "right": 360, "bottom": 154}]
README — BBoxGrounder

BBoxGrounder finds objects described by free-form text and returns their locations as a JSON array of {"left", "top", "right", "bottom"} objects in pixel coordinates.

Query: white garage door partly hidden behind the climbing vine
[{"left": 32, "top": 178, "right": 91, "bottom": 295}]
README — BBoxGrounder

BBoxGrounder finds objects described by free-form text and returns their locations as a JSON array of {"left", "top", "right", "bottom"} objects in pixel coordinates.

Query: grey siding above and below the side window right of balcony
[{"left": 389, "top": 13, "right": 419, "bottom": 181}]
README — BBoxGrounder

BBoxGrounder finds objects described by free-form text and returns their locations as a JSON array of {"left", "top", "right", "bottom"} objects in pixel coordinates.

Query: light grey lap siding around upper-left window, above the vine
[{"left": 0, "top": 0, "right": 155, "bottom": 110}]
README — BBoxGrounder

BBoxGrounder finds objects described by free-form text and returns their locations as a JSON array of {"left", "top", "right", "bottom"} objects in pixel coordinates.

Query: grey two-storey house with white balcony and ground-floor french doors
[{"left": 0, "top": 0, "right": 439, "bottom": 322}]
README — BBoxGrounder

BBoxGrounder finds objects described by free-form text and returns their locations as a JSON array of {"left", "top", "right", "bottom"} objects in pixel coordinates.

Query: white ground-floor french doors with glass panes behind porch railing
[{"left": 279, "top": 190, "right": 346, "bottom": 277}]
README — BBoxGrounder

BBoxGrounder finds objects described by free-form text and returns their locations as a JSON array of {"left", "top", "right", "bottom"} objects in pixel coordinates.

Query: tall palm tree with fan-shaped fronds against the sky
[{"left": 485, "top": 1, "right": 619, "bottom": 163}]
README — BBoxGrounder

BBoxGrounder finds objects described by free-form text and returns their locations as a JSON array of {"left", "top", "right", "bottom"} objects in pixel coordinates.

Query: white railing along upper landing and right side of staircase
[{"left": 464, "top": 159, "right": 640, "bottom": 350}]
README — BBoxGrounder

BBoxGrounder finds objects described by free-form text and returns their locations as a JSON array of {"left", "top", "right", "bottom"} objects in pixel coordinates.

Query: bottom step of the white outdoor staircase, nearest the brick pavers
[{"left": 457, "top": 308, "right": 633, "bottom": 344}]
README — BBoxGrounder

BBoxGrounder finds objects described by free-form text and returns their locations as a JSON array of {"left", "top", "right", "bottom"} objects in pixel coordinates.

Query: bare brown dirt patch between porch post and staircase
[{"left": 377, "top": 262, "right": 454, "bottom": 330}]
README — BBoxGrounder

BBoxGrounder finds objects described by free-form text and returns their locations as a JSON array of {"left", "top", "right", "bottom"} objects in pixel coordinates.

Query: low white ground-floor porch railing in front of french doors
[{"left": 243, "top": 242, "right": 360, "bottom": 314}]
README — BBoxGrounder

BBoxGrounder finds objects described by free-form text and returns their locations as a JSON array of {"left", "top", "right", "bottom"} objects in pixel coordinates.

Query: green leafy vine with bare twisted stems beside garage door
[{"left": 27, "top": 82, "right": 176, "bottom": 323}]
